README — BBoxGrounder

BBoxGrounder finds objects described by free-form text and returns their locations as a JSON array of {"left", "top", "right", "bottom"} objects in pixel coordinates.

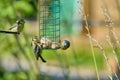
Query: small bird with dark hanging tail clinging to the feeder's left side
[{"left": 31, "top": 36, "right": 46, "bottom": 62}]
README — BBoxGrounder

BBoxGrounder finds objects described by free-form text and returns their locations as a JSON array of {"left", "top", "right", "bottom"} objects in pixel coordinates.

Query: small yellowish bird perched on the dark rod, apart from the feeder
[{"left": 8, "top": 19, "right": 25, "bottom": 33}]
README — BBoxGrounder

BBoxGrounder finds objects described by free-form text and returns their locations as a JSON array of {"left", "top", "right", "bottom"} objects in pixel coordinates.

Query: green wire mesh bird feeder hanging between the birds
[{"left": 38, "top": 0, "right": 60, "bottom": 49}]
